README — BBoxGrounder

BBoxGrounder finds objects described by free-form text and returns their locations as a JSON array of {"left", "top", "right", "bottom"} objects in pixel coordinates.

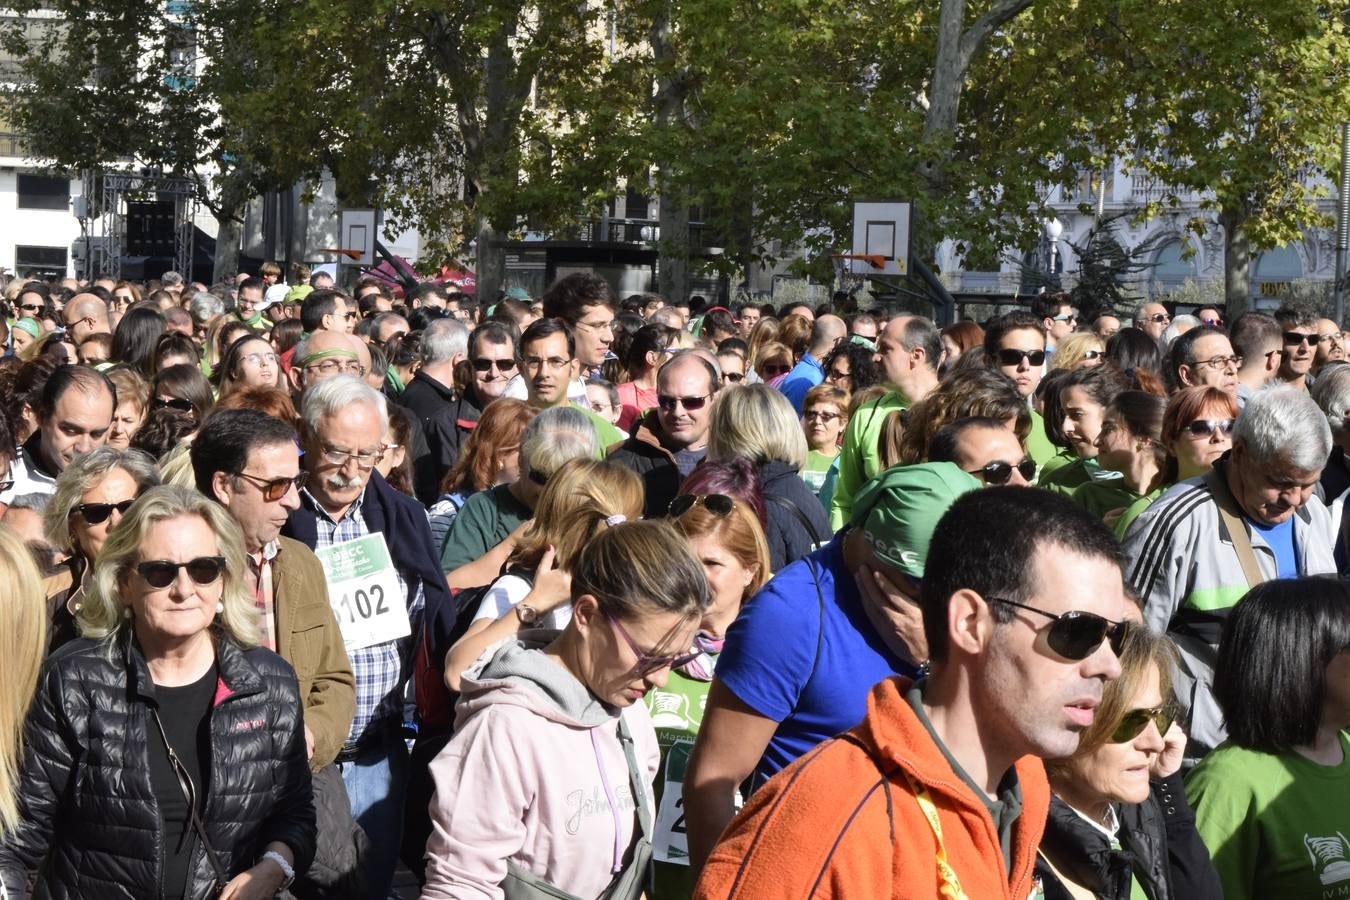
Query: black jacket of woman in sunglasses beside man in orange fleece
[{"left": 1035, "top": 773, "right": 1223, "bottom": 900}]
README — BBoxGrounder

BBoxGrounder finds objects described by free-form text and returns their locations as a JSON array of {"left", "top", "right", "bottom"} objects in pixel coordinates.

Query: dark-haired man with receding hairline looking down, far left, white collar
[{"left": 0, "top": 366, "right": 117, "bottom": 506}]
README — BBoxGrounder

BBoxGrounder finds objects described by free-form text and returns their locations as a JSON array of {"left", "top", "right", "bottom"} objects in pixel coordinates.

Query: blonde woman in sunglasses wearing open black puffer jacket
[{"left": 0, "top": 487, "right": 315, "bottom": 900}]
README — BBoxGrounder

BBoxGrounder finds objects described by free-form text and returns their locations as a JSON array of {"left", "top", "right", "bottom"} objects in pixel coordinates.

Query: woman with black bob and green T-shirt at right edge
[{"left": 1185, "top": 578, "right": 1350, "bottom": 900}]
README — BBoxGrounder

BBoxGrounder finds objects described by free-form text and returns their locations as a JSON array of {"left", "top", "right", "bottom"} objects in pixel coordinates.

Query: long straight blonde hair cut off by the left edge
[{"left": 0, "top": 525, "right": 47, "bottom": 837}]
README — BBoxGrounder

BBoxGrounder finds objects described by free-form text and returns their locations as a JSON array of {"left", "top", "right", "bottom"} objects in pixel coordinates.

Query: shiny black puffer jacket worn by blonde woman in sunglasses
[{"left": 0, "top": 629, "right": 315, "bottom": 900}]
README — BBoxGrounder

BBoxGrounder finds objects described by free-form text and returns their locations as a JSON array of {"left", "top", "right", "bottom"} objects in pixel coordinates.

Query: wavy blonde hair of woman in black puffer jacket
[{"left": 77, "top": 484, "right": 258, "bottom": 646}]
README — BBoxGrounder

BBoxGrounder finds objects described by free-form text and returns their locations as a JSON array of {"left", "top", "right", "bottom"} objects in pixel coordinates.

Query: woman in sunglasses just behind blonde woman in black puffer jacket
[{"left": 46, "top": 447, "right": 159, "bottom": 650}]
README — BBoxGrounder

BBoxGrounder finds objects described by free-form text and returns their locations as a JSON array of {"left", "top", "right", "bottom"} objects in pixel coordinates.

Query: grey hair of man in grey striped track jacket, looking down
[{"left": 1233, "top": 386, "right": 1331, "bottom": 472}]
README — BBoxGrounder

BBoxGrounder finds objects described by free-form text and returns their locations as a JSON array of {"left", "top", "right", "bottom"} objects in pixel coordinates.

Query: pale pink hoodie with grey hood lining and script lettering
[{"left": 421, "top": 636, "right": 660, "bottom": 900}]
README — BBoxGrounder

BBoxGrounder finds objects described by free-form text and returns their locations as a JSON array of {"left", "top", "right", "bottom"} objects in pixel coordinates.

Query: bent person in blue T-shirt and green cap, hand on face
[{"left": 684, "top": 463, "right": 980, "bottom": 866}]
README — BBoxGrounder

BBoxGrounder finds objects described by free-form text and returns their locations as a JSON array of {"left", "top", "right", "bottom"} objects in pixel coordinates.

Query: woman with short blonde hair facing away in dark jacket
[{"left": 707, "top": 385, "right": 832, "bottom": 572}]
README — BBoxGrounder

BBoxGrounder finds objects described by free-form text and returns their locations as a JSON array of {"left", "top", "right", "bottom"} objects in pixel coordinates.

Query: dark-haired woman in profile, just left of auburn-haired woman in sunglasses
[{"left": 1072, "top": 390, "right": 1166, "bottom": 528}]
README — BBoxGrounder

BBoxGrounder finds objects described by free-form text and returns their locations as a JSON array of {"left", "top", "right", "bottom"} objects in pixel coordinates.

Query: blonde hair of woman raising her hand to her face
[{"left": 510, "top": 457, "right": 645, "bottom": 569}]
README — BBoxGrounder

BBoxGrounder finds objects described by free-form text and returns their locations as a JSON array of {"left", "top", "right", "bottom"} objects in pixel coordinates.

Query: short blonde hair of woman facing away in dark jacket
[{"left": 707, "top": 385, "right": 807, "bottom": 471}]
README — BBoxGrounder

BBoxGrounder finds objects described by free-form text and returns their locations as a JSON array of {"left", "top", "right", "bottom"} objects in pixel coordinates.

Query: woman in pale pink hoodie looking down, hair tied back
[{"left": 421, "top": 521, "right": 709, "bottom": 900}]
